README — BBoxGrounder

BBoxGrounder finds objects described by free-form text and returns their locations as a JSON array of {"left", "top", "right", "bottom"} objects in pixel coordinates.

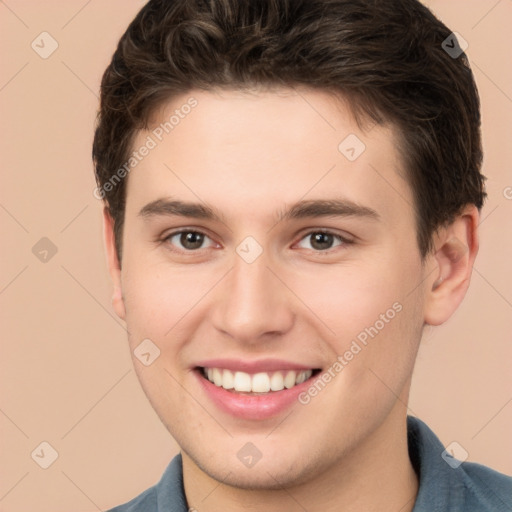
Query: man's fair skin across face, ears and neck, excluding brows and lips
[{"left": 104, "top": 89, "right": 478, "bottom": 512}]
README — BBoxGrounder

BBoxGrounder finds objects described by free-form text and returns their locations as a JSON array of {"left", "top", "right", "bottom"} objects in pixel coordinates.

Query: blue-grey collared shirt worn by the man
[{"left": 108, "top": 416, "right": 512, "bottom": 512}]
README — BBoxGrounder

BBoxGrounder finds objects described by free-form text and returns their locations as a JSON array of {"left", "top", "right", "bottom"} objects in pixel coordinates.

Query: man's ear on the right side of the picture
[{"left": 425, "top": 205, "right": 480, "bottom": 325}]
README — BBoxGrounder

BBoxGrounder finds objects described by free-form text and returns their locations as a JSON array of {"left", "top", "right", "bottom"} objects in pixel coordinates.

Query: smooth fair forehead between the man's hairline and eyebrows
[{"left": 127, "top": 89, "right": 412, "bottom": 225}]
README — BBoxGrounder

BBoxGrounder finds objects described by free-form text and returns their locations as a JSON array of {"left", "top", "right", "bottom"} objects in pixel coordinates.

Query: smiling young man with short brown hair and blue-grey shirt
[{"left": 93, "top": 0, "right": 512, "bottom": 512}]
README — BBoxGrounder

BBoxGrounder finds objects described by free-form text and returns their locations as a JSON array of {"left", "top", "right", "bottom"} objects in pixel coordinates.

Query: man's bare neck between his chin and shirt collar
[{"left": 182, "top": 404, "right": 418, "bottom": 512}]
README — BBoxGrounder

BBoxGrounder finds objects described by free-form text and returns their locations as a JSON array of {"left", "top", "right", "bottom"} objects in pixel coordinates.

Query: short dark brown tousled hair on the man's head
[{"left": 93, "top": 0, "right": 486, "bottom": 259}]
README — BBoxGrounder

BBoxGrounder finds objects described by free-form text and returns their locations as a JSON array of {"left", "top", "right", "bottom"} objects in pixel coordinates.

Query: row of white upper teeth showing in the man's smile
[{"left": 203, "top": 368, "right": 313, "bottom": 393}]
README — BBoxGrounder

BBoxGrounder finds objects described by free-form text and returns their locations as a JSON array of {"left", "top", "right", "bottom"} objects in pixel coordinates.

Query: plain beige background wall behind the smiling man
[{"left": 0, "top": 0, "right": 512, "bottom": 512}]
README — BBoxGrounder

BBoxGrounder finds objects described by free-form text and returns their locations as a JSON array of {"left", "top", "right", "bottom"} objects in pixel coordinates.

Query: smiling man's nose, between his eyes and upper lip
[{"left": 212, "top": 251, "right": 295, "bottom": 344}]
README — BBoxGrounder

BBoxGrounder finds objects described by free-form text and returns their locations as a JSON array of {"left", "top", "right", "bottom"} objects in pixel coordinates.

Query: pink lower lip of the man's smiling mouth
[{"left": 194, "top": 370, "right": 316, "bottom": 420}]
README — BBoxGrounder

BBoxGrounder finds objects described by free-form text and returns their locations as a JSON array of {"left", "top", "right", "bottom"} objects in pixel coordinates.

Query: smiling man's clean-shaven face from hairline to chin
[{"left": 110, "top": 89, "right": 427, "bottom": 488}]
